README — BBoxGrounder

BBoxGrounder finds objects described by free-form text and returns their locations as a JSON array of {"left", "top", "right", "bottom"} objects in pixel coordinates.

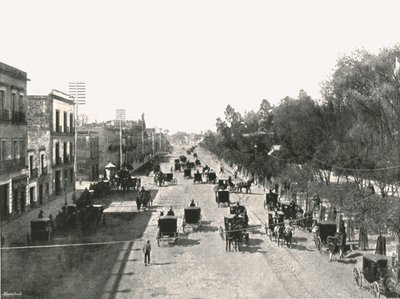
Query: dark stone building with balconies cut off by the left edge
[{"left": 0, "top": 63, "right": 29, "bottom": 220}]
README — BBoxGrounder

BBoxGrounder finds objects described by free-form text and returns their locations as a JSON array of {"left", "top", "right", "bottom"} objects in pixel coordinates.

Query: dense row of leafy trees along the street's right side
[{"left": 202, "top": 45, "right": 400, "bottom": 241}]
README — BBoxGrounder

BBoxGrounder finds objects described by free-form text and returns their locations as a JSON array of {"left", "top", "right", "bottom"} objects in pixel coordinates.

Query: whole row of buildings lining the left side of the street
[{"left": 0, "top": 63, "right": 169, "bottom": 221}]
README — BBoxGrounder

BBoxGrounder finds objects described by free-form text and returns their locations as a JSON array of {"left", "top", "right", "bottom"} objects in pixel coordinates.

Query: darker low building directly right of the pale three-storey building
[{"left": 76, "top": 131, "right": 100, "bottom": 180}]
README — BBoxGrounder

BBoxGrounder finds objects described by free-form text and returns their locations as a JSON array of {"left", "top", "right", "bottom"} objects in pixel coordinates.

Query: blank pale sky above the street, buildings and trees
[{"left": 0, "top": 0, "right": 400, "bottom": 133}]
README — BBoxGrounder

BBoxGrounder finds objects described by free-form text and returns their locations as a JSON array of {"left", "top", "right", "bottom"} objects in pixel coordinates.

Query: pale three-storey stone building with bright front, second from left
[{"left": 29, "top": 90, "right": 75, "bottom": 203}]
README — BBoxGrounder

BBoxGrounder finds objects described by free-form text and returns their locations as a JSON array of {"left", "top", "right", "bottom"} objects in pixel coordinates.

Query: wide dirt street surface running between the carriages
[{"left": 2, "top": 149, "right": 371, "bottom": 299}]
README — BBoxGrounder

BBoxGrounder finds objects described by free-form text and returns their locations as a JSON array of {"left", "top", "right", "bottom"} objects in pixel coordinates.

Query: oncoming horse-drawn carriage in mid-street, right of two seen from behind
[{"left": 219, "top": 215, "right": 249, "bottom": 251}]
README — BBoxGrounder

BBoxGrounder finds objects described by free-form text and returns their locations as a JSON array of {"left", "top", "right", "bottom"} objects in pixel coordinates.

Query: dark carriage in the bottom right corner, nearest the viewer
[{"left": 353, "top": 254, "right": 400, "bottom": 298}]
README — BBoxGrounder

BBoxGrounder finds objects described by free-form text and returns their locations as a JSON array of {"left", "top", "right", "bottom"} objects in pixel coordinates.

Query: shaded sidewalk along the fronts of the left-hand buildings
[{"left": 1, "top": 181, "right": 90, "bottom": 247}]
